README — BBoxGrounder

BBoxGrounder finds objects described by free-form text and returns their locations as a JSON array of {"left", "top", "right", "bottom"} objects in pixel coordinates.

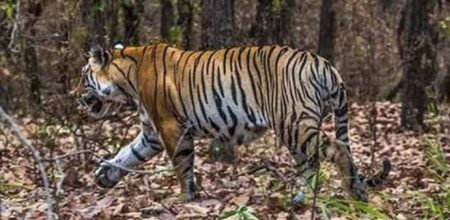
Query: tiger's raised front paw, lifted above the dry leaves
[{"left": 95, "top": 163, "right": 126, "bottom": 188}]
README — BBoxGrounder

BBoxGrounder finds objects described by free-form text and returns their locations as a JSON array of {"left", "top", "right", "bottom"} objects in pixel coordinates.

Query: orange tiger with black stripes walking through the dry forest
[{"left": 78, "top": 43, "right": 391, "bottom": 202}]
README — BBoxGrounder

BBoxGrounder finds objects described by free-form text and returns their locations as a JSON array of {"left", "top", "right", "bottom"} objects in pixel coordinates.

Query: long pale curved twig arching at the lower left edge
[{"left": 0, "top": 106, "right": 53, "bottom": 220}]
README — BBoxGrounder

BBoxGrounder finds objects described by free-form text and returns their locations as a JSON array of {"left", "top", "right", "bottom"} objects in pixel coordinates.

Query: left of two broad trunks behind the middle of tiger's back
[{"left": 202, "top": 0, "right": 234, "bottom": 49}]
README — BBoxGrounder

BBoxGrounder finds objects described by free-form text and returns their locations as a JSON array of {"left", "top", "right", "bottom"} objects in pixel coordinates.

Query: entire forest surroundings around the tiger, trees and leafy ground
[{"left": 0, "top": 0, "right": 450, "bottom": 219}]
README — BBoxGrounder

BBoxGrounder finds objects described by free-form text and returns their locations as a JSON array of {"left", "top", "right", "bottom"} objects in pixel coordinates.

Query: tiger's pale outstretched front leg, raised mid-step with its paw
[{"left": 95, "top": 125, "right": 162, "bottom": 188}]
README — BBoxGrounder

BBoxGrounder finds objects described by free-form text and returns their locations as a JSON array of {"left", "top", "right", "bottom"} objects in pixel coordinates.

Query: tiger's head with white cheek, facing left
[{"left": 78, "top": 46, "right": 133, "bottom": 118}]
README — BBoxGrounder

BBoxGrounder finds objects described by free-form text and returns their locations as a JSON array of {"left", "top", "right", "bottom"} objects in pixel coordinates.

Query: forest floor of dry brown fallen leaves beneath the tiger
[{"left": 0, "top": 102, "right": 450, "bottom": 219}]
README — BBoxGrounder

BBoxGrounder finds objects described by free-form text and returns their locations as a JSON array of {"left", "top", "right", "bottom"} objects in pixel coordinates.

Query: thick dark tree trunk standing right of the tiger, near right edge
[{"left": 398, "top": 0, "right": 438, "bottom": 129}]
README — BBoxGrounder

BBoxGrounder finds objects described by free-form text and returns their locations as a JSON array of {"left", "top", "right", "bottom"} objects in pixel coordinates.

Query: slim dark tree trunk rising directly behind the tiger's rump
[{"left": 317, "top": 0, "right": 336, "bottom": 62}]
